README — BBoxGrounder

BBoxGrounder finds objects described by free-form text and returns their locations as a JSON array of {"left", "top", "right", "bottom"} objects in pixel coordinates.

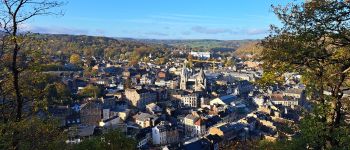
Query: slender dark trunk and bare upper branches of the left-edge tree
[{"left": 0, "top": 0, "right": 63, "bottom": 149}]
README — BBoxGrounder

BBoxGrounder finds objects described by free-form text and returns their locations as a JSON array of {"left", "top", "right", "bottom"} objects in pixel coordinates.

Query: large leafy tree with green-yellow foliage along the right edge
[{"left": 261, "top": 0, "right": 350, "bottom": 149}]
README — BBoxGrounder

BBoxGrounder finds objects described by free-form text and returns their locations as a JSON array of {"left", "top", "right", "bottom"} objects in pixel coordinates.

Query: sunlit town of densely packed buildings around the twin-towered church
[{"left": 47, "top": 47, "right": 309, "bottom": 150}]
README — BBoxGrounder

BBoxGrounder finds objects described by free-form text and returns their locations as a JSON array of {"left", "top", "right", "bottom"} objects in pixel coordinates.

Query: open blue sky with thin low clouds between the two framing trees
[{"left": 25, "top": 0, "right": 298, "bottom": 40}]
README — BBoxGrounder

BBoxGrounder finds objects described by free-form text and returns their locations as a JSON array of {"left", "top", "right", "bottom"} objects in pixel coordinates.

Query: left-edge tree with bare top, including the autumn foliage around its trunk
[{"left": 0, "top": 0, "right": 63, "bottom": 149}]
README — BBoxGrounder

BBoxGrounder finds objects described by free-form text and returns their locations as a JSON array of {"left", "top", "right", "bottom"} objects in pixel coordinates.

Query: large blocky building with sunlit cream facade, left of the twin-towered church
[{"left": 125, "top": 89, "right": 157, "bottom": 109}]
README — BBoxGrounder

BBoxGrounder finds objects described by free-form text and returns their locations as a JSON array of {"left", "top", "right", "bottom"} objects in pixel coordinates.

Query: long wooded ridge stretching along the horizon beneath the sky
[{"left": 0, "top": 32, "right": 259, "bottom": 58}]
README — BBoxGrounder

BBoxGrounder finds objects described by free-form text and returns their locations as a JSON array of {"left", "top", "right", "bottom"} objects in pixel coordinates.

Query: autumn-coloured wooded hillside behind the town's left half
[{"left": 15, "top": 34, "right": 172, "bottom": 58}]
